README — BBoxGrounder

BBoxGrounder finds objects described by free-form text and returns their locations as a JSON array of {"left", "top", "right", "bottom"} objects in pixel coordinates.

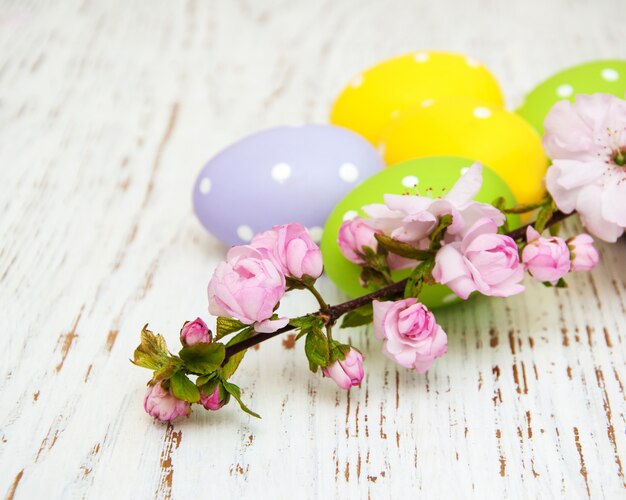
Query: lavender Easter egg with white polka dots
[{"left": 193, "top": 125, "right": 384, "bottom": 245}]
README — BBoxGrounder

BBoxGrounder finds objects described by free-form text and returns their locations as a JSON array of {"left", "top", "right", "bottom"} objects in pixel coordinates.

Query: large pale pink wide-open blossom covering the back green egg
[{"left": 543, "top": 94, "right": 626, "bottom": 242}]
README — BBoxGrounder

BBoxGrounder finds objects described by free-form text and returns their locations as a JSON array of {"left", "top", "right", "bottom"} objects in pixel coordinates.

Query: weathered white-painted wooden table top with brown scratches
[{"left": 0, "top": 0, "right": 626, "bottom": 499}]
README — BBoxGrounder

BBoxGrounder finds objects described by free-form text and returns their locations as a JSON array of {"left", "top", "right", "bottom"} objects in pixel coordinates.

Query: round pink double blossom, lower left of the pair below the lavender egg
[{"left": 208, "top": 245, "right": 285, "bottom": 329}]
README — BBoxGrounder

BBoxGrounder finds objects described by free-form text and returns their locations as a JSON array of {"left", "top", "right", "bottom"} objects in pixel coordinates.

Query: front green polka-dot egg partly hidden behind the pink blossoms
[{"left": 321, "top": 157, "right": 519, "bottom": 308}]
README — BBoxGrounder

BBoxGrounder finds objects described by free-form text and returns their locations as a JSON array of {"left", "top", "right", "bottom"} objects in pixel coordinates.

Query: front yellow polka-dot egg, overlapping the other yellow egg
[{"left": 379, "top": 97, "right": 548, "bottom": 203}]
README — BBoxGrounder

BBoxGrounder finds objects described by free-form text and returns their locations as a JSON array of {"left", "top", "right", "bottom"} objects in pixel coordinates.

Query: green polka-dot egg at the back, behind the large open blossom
[{"left": 517, "top": 59, "right": 626, "bottom": 134}]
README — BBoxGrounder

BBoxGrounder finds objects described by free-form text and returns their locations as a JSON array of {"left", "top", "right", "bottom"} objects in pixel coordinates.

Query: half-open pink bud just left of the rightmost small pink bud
[{"left": 522, "top": 226, "right": 570, "bottom": 285}]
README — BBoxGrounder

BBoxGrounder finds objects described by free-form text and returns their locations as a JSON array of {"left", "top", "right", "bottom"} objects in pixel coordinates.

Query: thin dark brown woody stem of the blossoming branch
[{"left": 224, "top": 211, "right": 576, "bottom": 364}]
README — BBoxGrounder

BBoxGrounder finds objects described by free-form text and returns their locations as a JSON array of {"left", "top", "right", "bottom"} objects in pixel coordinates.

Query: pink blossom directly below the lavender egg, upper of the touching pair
[{"left": 250, "top": 224, "right": 324, "bottom": 279}]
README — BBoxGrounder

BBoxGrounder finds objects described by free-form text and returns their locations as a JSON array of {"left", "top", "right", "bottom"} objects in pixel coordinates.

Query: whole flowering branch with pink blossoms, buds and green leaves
[{"left": 133, "top": 94, "right": 626, "bottom": 422}]
